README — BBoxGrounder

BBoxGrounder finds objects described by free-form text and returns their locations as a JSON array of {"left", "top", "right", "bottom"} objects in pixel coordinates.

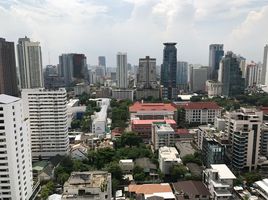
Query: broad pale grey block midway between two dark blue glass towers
[{"left": 190, "top": 66, "right": 208, "bottom": 92}]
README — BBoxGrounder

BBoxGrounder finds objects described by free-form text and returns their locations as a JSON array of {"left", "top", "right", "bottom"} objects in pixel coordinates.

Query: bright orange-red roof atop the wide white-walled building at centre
[{"left": 129, "top": 102, "right": 177, "bottom": 112}]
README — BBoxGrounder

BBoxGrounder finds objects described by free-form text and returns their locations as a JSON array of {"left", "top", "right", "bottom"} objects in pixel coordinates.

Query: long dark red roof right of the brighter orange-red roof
[{"left": 177, "top": 102, "right": 221, "bottom": 110}]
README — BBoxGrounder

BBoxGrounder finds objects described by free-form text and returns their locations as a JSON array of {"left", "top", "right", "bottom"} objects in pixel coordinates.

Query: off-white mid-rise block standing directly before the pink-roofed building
[{"left": 152, "top": 123, "right": 175, "bottom": 150}]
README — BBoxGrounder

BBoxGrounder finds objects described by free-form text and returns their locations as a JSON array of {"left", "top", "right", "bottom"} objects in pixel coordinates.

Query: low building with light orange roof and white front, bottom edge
[{"left": 128, "top": 183, "right": 175, "bottom": 200}]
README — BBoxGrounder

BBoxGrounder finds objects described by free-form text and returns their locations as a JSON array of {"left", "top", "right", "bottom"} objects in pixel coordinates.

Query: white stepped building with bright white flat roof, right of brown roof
[{"left": 203, "top": 164, "right": 236, "bottom": 200}]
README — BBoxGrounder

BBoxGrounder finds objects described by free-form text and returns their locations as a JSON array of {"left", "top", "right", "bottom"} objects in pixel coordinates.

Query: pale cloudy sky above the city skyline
[{"left": 0, "top": 0, "right": 268, "bottom": 67}]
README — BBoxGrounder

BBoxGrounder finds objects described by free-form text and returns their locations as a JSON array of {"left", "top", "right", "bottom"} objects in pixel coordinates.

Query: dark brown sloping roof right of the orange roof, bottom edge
[{"left": 172, "top": 181, "right": 210, "bottom": 196}]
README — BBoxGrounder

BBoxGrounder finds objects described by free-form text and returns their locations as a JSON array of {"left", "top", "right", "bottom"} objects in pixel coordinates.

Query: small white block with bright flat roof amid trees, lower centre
[{"left": 158, "top": 147, "right": 182, "bottom": 175}]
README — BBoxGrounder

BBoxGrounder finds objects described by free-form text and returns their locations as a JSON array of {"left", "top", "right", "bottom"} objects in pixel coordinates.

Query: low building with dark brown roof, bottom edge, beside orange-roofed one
[{"left": 172, "top": 181, "right": 210, "bottom": 200}]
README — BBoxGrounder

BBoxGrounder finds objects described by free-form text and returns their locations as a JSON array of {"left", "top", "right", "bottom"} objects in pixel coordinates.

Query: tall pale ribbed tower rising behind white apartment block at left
[{"left": 17, "top": 37, "right": 44, "bottom": 89}]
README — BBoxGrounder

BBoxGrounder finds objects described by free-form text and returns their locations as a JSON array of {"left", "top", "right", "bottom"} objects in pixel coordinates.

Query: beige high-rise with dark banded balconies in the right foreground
[{"left": 225, "top": 108, "right": 263, "bottom": 171}]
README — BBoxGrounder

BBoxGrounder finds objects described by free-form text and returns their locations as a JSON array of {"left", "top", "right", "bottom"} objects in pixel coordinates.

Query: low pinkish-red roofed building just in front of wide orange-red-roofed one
[{"left": 131, "top": 119, "right": 176, "bottom": 143}]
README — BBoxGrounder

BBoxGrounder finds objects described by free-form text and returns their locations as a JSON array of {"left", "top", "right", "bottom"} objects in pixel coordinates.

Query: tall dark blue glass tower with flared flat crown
[{"left": 161, "top": 43, "right": 177, "bottom": 99}]
